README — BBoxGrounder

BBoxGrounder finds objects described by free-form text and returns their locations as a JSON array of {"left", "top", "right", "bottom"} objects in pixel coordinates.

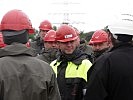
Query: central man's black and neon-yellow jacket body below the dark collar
[{"left": 50, "top": 59, "right": 92, "bottom": 100}]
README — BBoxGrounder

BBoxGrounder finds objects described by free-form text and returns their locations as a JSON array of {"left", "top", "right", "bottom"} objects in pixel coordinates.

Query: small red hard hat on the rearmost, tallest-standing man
[{"left": 39, "top": 20, "right": 52, "bottom": 31}]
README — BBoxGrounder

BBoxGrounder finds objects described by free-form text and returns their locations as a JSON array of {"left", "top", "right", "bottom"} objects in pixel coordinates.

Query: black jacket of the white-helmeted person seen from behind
[{"left": 85, "top": 44, "right": 133, "bottom": 100}]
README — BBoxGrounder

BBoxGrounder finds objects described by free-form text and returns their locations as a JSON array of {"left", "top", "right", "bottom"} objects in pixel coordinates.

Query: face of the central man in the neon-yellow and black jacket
[{"left": 58, "top": 40, "right": 77, "bottom": 54}]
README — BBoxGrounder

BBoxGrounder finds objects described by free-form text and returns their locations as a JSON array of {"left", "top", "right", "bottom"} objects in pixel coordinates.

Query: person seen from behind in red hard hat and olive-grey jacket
[{"left": 0, "top": 10, "right": 60, "bottom": 100}]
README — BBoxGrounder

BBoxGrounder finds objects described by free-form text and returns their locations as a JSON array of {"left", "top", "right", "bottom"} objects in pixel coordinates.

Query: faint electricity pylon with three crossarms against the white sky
[{"left": 49, "top": 0, "right": 85, "bottom": 30}]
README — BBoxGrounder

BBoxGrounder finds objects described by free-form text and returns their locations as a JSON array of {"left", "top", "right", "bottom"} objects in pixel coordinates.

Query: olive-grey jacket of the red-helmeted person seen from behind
[{"left": 0, "top": 43, "right": 60, "bottom": 100}]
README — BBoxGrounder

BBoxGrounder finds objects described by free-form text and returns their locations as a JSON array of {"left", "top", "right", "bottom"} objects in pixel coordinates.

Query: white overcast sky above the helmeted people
[{"left": 0, "top": 0, "right": 133, "bottom": 32}]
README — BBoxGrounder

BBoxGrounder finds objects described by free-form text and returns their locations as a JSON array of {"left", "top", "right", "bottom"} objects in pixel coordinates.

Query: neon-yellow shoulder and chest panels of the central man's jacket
[{"left": 50, "top": 59, "right": 92, "bottom": 81}]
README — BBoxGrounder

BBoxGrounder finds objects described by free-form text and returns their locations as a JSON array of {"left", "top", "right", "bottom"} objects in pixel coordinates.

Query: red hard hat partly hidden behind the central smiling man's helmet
[{"left": 43, "top": 30, "right": 56, "bottom": 41}]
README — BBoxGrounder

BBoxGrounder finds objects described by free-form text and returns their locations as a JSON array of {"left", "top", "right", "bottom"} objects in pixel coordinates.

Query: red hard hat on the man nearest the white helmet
[{"left": 89, "top": 30, "right": 109, "bottom": 45}]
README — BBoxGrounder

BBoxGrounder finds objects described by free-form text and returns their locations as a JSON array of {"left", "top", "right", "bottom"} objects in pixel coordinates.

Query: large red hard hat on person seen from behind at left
[{"left": 0, "top": 9, "right": 34, "bottom": 33}]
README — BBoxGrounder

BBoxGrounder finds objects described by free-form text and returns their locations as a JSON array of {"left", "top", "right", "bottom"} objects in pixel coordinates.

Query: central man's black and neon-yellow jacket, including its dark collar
[{"left": 50, "top": 49, "right": 92, "bottom": 100}]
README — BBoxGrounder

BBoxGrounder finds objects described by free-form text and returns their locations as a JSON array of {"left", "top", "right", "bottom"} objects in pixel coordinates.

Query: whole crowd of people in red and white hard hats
[{"left": 0, "top": 9, "right": 133, "bottom": 100}]
